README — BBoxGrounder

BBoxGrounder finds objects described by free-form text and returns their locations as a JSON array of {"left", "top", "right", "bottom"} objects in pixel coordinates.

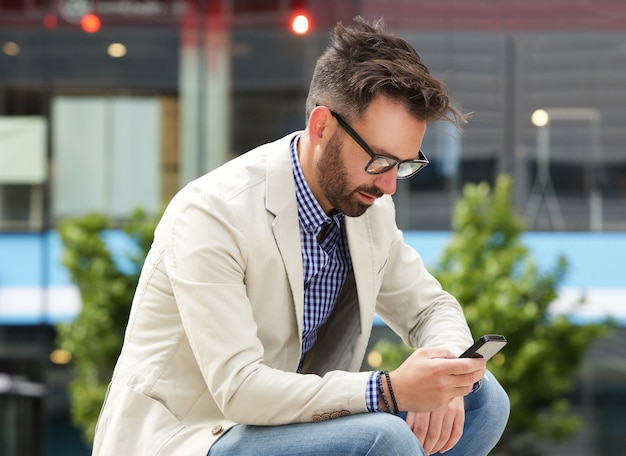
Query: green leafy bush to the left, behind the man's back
[{"left": 57, "top": 210, "right": 156, "bottom": 443}]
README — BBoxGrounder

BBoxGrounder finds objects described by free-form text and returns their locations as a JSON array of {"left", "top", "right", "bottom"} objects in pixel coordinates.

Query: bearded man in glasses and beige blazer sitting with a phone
[{"left": 94, "top": 18, "right": 509, "bottom": 456}]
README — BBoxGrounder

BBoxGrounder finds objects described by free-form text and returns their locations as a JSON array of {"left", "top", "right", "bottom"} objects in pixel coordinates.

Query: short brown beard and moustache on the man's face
[{"left": 317, "top": 133, "right": 384, "bottom": 217}]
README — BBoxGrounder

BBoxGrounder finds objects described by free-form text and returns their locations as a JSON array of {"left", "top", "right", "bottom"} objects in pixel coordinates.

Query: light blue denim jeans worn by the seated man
[{"left": 208, "top": 373, "right": 510, "bottom": 456}]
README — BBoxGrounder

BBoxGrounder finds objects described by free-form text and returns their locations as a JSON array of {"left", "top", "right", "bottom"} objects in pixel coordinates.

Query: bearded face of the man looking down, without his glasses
[{"left": 316, "top": 98, "right": 426, "bottom": 217}]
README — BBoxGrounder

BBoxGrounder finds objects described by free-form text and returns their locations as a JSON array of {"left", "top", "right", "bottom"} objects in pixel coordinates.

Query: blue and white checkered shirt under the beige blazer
[{"left": 291, "top": 137, "right": 380, "bottom": 411}]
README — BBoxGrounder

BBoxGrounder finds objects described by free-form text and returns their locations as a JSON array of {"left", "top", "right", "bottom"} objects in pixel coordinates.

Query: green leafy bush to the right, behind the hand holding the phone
[{"left": 433, "top": 175, "right": 608, "bottom": 450}]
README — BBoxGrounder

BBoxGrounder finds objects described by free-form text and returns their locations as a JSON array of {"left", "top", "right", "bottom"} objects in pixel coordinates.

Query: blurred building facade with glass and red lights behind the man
[{"left": 0, "top": 0, "right": 626, "bottom": 455}]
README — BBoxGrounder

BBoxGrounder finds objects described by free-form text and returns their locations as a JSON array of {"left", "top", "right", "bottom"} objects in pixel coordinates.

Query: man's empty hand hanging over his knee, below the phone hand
[{"left": 406, "top": 397, "right": 465, "bottom": 454}]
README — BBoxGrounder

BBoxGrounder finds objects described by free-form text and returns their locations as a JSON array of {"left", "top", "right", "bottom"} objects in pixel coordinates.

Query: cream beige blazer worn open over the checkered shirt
[{"left": 93, "top": 134, "right": 472, "bottom": 456}]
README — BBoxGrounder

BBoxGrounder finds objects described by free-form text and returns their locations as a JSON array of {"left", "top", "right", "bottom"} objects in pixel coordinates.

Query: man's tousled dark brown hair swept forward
[{"left": 306, "top": 17, "right": 469, "bottom": 129}]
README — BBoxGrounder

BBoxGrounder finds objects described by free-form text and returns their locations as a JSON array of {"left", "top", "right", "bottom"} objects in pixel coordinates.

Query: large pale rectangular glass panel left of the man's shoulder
[{"left": 53, "top": 97, "right": 161, "bottom": 218}]
